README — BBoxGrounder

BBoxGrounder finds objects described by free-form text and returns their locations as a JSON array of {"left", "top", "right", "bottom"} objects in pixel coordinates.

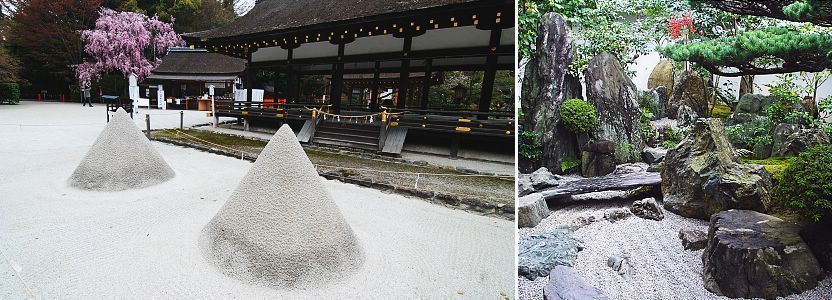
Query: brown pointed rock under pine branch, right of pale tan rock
[{"left": 666, "top": 71, "right": 709, "bottom": 119}]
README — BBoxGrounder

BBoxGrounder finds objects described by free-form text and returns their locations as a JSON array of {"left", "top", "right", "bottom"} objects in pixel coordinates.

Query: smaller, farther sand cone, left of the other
[{"left": 68, "top": 108, "right": 176, "bottom": 191}]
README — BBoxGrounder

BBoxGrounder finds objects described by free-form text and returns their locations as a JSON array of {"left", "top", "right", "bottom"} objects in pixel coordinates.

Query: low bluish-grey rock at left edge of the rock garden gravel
[{"left": 517, "top": 228, "right": 583, "bottom": 280}]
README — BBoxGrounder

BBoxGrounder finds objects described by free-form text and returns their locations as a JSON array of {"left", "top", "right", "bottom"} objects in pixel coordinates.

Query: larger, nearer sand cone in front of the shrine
[{"left": 200, "top": 125, "right": 364, "bottom": 289}]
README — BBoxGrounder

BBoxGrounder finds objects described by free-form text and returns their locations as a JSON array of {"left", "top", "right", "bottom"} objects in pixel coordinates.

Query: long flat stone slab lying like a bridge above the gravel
[{"left": 540, "top": 172, "right": 662, "bottom": 200}]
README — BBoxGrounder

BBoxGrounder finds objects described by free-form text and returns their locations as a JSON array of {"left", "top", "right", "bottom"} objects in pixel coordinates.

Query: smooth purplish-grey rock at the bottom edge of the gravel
[{"left": 543, "top": 266, "right": 609, "bottom": 300}]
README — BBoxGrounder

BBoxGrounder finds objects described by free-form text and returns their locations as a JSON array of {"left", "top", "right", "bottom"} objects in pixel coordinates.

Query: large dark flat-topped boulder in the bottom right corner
[{"left": 702, "top": 210, "right": 821, "bottom": 299}]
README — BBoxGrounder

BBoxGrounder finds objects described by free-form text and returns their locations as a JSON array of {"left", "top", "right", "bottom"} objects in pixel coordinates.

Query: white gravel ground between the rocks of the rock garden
[{"left": 518, "top": 201, "right": 832, "bottom": 300}]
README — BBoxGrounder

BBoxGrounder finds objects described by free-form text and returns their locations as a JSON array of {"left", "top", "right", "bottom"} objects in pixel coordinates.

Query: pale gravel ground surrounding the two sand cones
[{"left": 0, "top": 104, "right": 515, "bottom": 299}]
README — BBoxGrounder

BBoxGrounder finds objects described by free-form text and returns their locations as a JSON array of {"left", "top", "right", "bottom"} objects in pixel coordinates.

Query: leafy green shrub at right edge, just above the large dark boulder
[{"left": 774, "top": 146, "right": 832, "bottom": 222}]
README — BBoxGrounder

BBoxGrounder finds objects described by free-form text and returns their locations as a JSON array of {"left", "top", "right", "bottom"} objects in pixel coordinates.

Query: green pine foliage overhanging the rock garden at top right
[{"left": 659, "top": 0, "right": 832, "bottom": 76}]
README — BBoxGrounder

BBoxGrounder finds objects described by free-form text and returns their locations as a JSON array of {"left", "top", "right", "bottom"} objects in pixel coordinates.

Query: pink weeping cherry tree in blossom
[{"left": 75, "top": 8, "right": 185, "bottom": 86}]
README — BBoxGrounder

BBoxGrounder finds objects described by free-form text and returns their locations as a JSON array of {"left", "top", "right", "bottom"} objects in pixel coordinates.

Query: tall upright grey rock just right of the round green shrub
[{"left": 584, "top": 53, "right": 644, "bottom": 159}]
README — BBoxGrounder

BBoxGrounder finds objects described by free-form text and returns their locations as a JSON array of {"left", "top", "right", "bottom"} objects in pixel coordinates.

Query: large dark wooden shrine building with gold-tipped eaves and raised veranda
[{"left": 184, "top": 0, "right": 516, "bottom": 156}]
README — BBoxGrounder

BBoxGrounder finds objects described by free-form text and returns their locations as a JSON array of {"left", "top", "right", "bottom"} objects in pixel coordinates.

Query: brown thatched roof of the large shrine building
[{"left": 184, "top": 0, "right": 480, "bottom": 39}]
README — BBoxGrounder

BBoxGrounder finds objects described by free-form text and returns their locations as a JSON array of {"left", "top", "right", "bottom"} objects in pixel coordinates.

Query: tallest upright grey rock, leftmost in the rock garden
[{"left": 520, "top": 13, "right": 581, "bottom": 172}]
